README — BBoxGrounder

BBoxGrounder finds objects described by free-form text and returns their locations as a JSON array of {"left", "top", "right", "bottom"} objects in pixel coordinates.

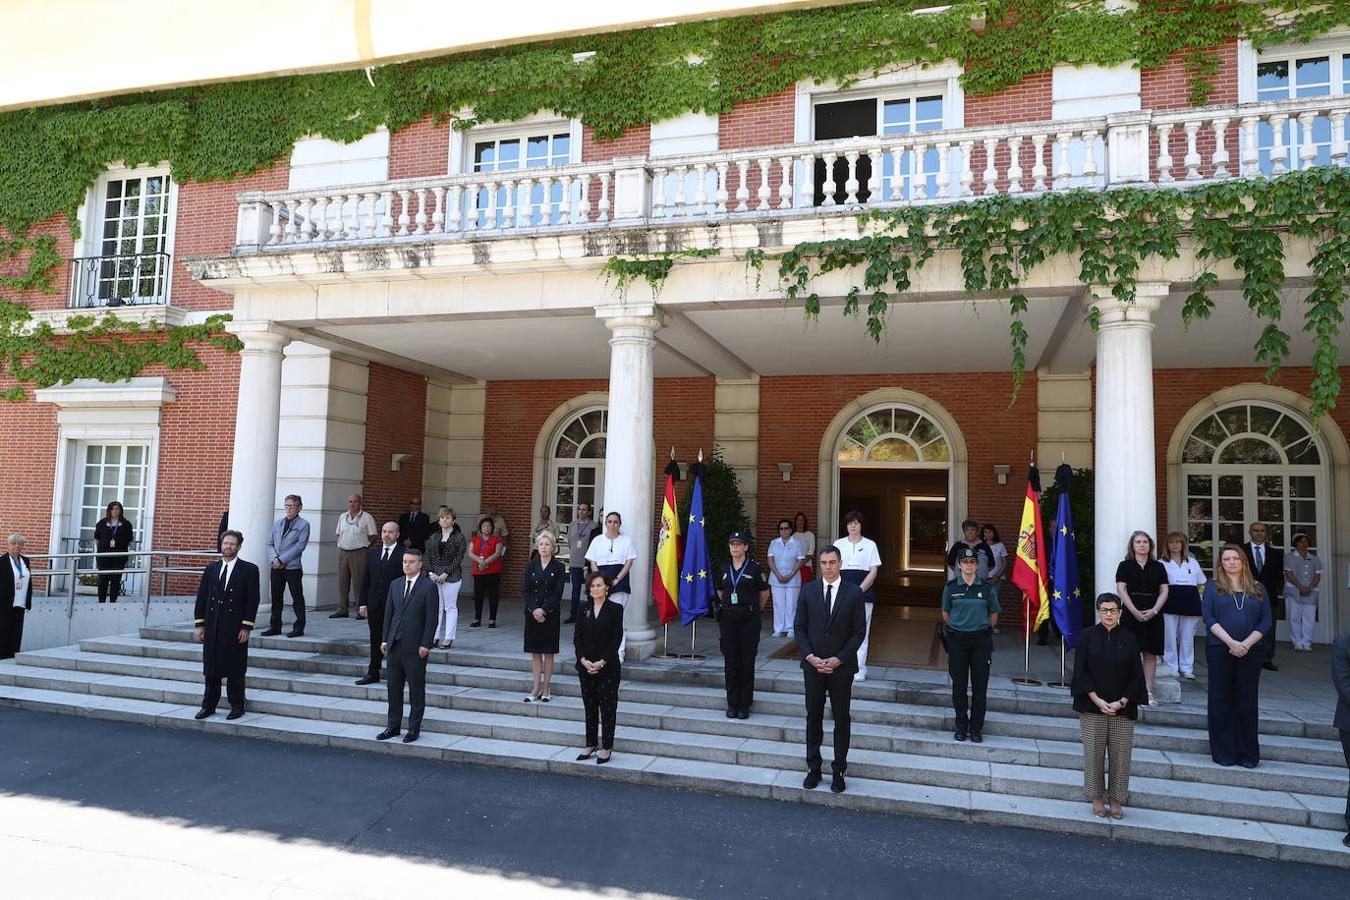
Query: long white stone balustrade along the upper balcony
[{"left": 238, "top": 96, "right": 1350, "bottom": 250}]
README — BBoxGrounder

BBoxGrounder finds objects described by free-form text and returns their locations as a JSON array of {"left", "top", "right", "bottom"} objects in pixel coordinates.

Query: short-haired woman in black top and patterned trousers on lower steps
[{"left": 1069, "top": 594, "right": 1148, "bottom": 819}]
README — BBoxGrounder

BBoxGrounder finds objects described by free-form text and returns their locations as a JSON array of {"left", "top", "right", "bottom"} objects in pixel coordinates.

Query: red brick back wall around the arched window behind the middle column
[{"left": 483, "top": 376, "right": 714, "bottom": 596}]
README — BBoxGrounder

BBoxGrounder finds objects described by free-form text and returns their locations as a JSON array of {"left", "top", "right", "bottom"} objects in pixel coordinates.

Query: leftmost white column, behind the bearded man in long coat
[{"left": 228, "top": 322, "right": 289, "bottom": 572}]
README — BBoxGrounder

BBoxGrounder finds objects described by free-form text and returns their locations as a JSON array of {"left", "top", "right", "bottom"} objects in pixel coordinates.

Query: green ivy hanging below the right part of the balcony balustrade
[{"left": 748, "top": 167, "right": 1350, "bottom": 420}]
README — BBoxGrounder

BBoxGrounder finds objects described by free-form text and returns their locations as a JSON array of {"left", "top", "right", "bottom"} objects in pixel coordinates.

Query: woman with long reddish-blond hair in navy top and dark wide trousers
[{"left": 1200, "top": 544, "right": 1273, "bottom": 769}]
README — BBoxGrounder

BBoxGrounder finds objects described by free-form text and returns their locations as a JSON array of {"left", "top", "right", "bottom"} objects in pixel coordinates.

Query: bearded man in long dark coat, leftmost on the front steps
[{"left": 194, "top": 530, "right": 262, "bottom": 719}]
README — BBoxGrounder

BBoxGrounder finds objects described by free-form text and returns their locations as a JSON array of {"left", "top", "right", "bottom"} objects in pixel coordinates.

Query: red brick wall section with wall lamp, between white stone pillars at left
[{"left": 362, "top": 363, "right": 423, "bottom": 524}]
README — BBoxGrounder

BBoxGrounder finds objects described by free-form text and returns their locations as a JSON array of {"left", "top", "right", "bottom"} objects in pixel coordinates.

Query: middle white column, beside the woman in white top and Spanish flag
[{"left": 598, "top": 305, "right": 660, "bottom": 660}]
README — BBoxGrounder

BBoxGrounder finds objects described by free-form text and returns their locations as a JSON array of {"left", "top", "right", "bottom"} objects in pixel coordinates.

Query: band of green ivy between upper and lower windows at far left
[{"left": 0, "top": 300, "right": 243, "bottom": 402}]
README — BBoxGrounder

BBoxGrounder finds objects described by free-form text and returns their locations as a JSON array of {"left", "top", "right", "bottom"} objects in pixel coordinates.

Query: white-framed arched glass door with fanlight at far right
[{"left": 1180, "top": 399, "right": 1338, "bottom": 641}]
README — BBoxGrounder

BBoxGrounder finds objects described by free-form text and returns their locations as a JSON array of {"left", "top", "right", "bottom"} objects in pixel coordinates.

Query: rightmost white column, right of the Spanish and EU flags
[{"left": 1091, "top": 282, "right": 1169, "bottom": 594}]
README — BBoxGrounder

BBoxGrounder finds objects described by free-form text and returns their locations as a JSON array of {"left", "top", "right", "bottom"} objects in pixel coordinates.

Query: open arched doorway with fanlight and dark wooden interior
[{"left": 821, "top": 399, "right": 964, "bottom": 606}]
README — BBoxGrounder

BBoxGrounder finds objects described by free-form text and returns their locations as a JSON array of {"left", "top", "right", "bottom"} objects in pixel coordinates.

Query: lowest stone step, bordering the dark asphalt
[{"left": 0, "top": 691, "right": 1350, "bottom": 869}]
